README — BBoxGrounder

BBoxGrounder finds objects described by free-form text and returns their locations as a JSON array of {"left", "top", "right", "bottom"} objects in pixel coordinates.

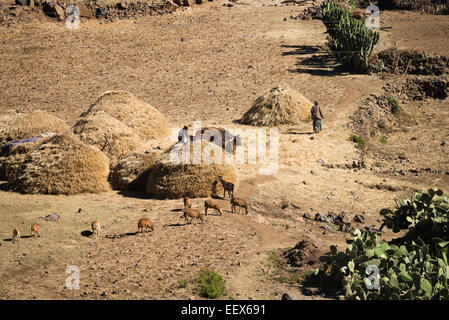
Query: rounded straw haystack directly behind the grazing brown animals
[{"left": 146, "top": 140, "right": 237, "bottom": 199}]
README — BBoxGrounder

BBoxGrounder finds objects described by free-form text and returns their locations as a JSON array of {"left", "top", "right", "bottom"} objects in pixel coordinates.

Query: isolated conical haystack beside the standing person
[{"left": 241, "top": 87, "right": 312, "bottom": 126}]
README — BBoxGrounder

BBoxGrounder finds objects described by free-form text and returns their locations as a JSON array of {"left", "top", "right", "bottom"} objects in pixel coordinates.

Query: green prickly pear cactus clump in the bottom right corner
[{"left": 306, "top": 189, "right": 449, "bottom": 300}]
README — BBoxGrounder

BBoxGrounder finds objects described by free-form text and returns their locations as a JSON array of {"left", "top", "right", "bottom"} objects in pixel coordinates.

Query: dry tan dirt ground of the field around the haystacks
[{"left": 0, "top": 0, "right": 449, "bottom": 299}]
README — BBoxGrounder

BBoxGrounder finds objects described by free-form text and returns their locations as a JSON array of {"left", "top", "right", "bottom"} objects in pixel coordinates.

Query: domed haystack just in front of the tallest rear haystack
[{"left": 73, "top": 114, "right": 143, "bottom": 163}]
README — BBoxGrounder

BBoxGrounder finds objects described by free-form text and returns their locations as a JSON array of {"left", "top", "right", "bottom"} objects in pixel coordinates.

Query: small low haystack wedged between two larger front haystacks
[{"left": 109, "top": 151, "right": 161, "bottom": 190}]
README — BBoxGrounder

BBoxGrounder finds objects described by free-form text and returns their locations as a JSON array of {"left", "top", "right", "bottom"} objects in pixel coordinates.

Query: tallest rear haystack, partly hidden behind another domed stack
[{"left": 81, "top": 91, "right": 170, "bottom": 141}]
